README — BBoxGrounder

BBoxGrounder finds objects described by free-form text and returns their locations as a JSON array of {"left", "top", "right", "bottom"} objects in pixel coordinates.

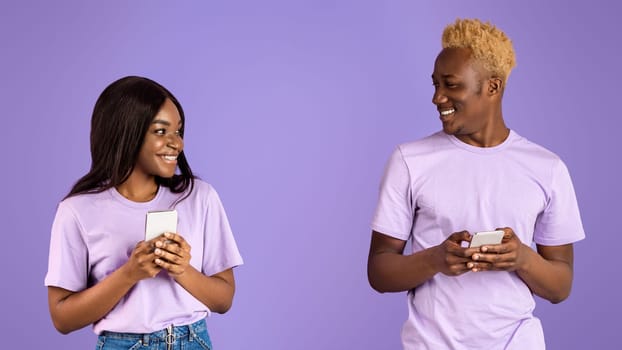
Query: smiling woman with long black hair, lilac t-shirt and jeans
[{"left": 45, "top": 76, "right": 242, "bottom": 349}]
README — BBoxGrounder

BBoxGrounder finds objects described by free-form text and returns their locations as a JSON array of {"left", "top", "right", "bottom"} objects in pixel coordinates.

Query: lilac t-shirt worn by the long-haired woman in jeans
[{"left": 45, "top": 180, "right": 242, "bottom": 334}]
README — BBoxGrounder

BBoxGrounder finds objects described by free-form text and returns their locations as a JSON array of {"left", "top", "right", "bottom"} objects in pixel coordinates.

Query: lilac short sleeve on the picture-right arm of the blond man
[{"left": 534, "top": 160, "right": 585, "bottom": 246}]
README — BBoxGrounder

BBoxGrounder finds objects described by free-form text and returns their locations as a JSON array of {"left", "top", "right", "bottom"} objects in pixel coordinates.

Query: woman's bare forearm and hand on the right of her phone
[{"left": 155, "top": 233, "right": 235, "bottom": 314}]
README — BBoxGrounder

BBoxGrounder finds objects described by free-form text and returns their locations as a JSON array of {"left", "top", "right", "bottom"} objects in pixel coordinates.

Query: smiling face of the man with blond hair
[{"left": 432, "top": 48, "right": 494, "bottom": 136}]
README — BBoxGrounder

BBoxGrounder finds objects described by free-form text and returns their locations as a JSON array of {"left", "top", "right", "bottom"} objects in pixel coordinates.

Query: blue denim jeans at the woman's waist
[{"left": 96, "top": 320, "right": 212, "bottom": 350}]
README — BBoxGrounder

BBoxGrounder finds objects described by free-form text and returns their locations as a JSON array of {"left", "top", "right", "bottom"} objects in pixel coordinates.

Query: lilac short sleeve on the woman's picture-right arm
[{"left": 202, "top": 188, "right": 243, "bottom": 276}]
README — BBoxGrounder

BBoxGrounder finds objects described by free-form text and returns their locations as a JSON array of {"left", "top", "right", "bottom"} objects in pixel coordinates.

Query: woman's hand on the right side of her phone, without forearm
[{"left": 155, "top": 233, "right": 191, "bottom": 278}]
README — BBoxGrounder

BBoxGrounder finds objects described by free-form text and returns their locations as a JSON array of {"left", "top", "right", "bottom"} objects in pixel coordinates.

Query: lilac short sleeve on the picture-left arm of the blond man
[{"left": 371, "top": 147, "right": 414, "bottom": 241}]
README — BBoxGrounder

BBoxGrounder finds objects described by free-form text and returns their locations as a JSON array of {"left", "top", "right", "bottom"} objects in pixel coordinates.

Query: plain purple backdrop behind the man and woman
[{"left": 0, "top": 0, "right": 622, "bottom": 349}]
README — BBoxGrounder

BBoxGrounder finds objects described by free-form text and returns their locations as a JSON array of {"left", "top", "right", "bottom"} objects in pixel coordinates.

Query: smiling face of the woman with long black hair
[{"left": 133, "top": 99, "right": 184, "bottom": 178}]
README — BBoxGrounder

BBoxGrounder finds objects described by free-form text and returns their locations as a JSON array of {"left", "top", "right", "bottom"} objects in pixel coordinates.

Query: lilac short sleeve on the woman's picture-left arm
[{"left": 45, "top": 202, "right": 88, "bottom": 292}]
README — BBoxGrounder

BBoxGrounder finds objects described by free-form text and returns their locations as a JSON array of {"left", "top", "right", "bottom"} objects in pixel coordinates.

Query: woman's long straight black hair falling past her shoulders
[{"left": 65, "top": 76, "right": 194, "bottom": 200}]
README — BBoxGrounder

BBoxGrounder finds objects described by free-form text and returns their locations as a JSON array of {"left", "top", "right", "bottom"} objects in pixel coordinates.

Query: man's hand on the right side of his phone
[{"left": 467, "top": 227, "right": 531, "bottom": 271}]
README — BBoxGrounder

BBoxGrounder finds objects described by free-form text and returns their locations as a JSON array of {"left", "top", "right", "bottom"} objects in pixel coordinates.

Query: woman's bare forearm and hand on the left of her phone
[{"left": 48, "top": 242, "right": 161, "bottom": 334}]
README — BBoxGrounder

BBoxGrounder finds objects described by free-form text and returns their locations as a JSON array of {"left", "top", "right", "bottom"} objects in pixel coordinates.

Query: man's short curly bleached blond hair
[{"left": 442, "top": 18, "right": 516, "bottom": 84}]
